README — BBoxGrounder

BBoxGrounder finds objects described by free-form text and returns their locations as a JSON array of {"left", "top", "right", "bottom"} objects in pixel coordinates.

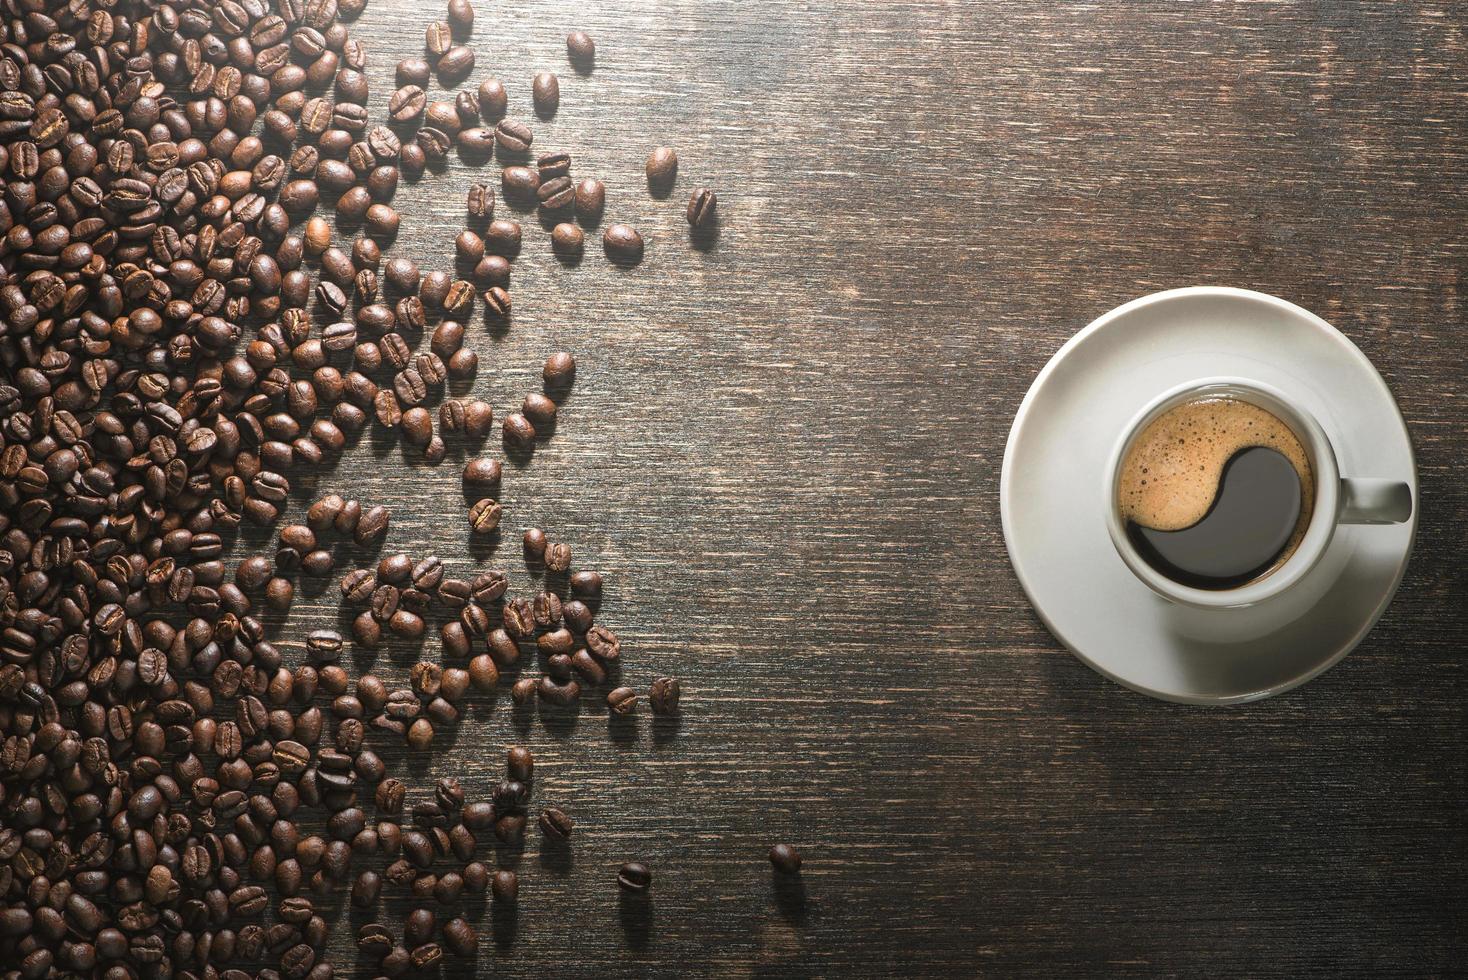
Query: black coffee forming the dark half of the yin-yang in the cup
[{"left": 1126, "top": 446, "right": 1302, "bottom": 588}]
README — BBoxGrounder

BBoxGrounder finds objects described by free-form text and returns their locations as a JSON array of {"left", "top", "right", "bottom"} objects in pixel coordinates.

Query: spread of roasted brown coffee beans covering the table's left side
[{"left": 0, "top": 0, "right": 704, "bottom": 980}]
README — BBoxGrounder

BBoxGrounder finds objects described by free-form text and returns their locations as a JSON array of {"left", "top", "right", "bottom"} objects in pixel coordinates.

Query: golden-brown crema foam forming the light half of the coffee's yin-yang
[{"left": 1117, "top": 396, "right": 1315, "bottom": 531}]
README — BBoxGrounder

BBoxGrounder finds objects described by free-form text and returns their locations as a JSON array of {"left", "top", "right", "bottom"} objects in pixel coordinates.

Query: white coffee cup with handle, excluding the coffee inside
[{"left": 1104, "top": 377, "right": 1412, "bottom": 609}]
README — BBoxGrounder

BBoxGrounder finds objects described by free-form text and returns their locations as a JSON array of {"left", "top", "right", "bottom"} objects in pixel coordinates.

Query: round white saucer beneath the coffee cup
[{"left": 1000, "top": 288, "right": 1418, "bottom": 704}]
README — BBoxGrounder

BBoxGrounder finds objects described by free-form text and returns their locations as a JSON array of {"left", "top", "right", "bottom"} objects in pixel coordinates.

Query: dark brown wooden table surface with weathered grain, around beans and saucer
[{"left": 298, "top": 0, "right": 1468, "bottom": 977}]
